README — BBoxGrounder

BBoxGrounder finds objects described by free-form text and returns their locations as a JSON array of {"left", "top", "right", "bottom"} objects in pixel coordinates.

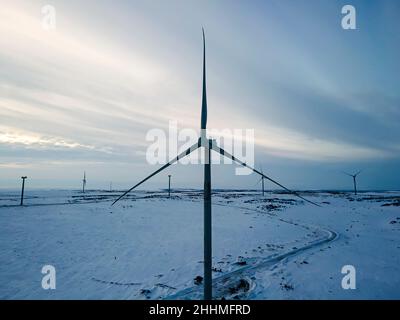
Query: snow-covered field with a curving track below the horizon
[{"left": 0, "top": 190, "right": 400, "bottom": 299}]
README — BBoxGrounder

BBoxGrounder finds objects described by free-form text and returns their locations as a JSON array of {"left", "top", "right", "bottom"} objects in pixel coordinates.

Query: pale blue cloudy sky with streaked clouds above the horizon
[{"left": 0, "top": 0, "right": 400, "bottom": 189}]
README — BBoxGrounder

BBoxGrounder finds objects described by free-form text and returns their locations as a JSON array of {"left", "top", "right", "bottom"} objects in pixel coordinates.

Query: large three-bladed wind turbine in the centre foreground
[{"left": 112, "top": 29, "right": 319, "bottom": 300}]
